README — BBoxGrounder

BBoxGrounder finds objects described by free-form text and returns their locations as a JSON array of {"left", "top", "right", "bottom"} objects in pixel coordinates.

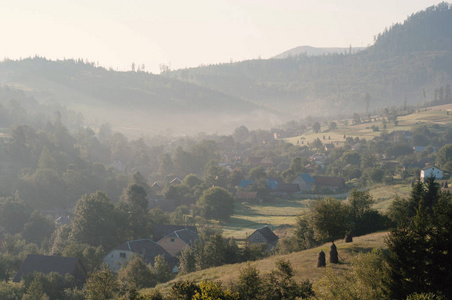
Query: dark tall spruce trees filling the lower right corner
[{"left": 386, "top": 180, "right": 452, "bottom": 299}]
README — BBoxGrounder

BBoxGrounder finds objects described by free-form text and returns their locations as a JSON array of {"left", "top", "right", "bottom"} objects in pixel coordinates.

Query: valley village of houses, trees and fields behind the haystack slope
[{"left": 2, "top": 92, "right": 452, "bottom": 298}]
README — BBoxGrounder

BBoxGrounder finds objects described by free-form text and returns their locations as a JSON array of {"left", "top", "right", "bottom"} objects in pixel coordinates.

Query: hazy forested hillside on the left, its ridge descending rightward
[{"left": 0, "top": 57, "right": 270, "bottom": 134}]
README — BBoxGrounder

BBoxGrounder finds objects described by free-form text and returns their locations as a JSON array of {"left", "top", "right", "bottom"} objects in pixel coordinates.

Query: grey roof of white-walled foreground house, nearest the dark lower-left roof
[{"left": 114, "top": 239, "right": 176, "bottom": 267}]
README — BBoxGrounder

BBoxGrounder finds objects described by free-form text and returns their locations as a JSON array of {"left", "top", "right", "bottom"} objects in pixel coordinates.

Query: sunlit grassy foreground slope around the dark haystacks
[{"left": 148, "top": 232, "right": 388, "bottom": 292}]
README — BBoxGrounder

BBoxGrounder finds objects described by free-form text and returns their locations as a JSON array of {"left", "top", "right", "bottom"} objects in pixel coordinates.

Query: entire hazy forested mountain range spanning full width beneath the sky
[{"left": 0, "top": 3, "right": 452, "bottom": 134}]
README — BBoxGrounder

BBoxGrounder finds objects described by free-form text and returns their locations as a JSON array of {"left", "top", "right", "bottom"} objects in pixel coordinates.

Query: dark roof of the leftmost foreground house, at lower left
[{"left": 13, "top": 254, "right": 86, "bottom": 283}]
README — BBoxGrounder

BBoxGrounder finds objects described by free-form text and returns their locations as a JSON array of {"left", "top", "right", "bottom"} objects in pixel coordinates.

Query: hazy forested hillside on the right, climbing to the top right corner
[{"left": 166, "top": 3, "right": 452, "bottom": 118}]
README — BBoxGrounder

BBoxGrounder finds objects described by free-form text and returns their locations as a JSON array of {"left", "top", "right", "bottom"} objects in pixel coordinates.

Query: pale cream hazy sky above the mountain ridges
[{"left": 0, "top": 0, "right": 441, "bottom": 73}]
